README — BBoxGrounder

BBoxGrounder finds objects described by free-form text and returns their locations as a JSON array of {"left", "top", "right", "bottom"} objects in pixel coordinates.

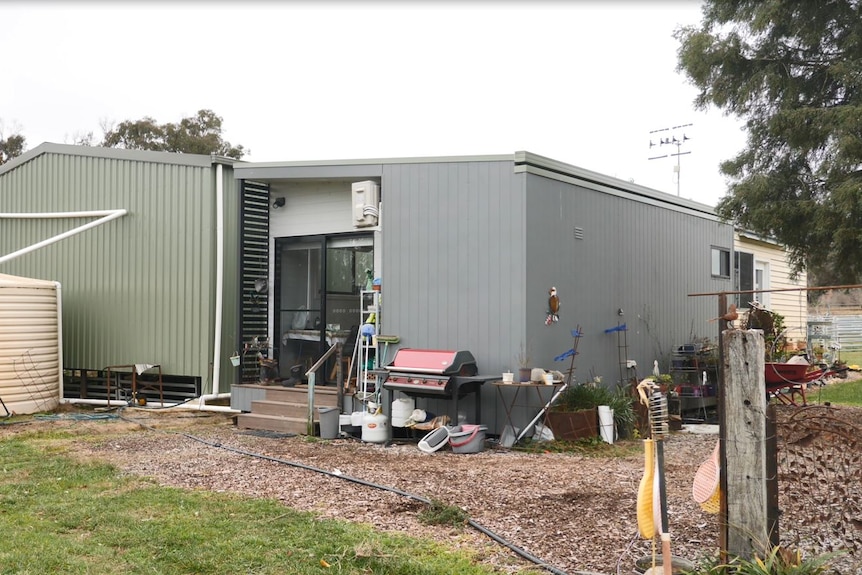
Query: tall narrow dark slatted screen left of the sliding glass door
[{"left": 240, "top": 180, "right": 270, "bottom": 383}]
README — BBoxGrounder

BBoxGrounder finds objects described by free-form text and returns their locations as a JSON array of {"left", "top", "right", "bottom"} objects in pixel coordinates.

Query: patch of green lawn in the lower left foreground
[{"left": 0, "top": 435, "right": 520, "bottom": 575}]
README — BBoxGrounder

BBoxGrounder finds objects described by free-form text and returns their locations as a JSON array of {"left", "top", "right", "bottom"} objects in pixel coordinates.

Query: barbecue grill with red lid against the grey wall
[{"left": 383, "top": 348, "right": 498, "bottom": 424}]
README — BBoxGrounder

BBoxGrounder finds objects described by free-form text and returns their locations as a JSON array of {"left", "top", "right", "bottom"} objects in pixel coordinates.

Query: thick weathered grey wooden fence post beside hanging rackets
[{"left": 721, "top": 329, "right": 770, "bottom": 559}]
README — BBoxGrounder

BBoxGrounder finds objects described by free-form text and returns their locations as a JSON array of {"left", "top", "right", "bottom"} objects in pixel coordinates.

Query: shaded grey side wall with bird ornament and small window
[{"left": 525, "top": 174, "right": 733, "bottom": 384}]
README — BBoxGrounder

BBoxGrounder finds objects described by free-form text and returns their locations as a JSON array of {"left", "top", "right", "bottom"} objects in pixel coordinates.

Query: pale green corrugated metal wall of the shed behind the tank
[{"left": 0, "top": 149, "right": 239, "bottom": 396}]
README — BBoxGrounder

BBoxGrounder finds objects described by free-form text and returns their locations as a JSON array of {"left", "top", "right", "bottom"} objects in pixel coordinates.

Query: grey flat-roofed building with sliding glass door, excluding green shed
[{"left": 234, "top": 152, "right": 733, "bottom": 427}]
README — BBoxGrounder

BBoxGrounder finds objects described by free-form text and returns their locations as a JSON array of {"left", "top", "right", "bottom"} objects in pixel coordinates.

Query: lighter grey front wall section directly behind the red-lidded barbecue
[{"left": 381, "top": 162, "right": 526, "bottom": 373}]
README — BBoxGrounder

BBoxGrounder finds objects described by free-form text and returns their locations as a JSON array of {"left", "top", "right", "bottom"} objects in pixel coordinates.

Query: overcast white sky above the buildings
[{"left": 0, "top": 0, "right": 745, "bottom": 205}]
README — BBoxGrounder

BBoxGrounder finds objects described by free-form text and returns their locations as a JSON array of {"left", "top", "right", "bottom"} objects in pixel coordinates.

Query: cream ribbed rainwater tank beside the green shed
[{"left": 0, "top": 274, "right": 63, "bottom": 416}]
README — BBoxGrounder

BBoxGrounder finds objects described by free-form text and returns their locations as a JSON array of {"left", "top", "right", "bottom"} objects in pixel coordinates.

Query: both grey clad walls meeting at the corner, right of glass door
[{"left": 374, "top": 155, "right": 733, "bottom": 432}]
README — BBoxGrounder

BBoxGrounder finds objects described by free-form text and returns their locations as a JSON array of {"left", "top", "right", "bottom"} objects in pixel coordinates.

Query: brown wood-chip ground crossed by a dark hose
[{"left": 0, "top": 398, "right": 859, "bottom": 574}]
